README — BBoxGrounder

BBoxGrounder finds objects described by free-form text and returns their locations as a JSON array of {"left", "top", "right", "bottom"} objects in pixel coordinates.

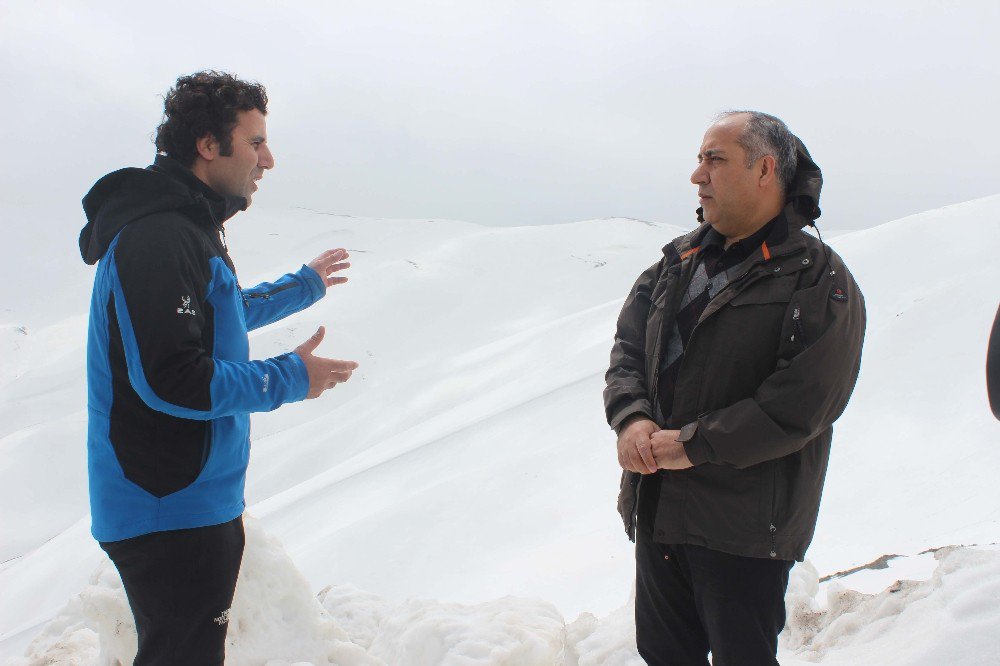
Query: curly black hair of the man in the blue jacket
[{"left": 154, "top": 70, "right": 267, "bottom": 167}]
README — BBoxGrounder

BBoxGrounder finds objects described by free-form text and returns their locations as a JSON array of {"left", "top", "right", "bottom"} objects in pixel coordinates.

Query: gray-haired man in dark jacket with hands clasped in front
[{"left": 604, "top": 111, "right": 865, "bottom": 666}]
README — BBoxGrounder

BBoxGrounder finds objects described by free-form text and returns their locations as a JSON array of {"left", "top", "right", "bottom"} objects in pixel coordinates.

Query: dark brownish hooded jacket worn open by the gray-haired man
[{"left": 604, "top": 147, "right": 865, "bottom": 560}]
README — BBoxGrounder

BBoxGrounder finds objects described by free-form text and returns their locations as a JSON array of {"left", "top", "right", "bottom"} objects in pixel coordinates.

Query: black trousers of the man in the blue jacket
[{"left": 101, "top": 516, "right": 245, "bottom": 666}]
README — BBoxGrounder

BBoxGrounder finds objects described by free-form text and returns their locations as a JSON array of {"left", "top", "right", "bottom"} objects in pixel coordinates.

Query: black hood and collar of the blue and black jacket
[{"left": 80, "top": 155, "right": 247, "bottom": 264}]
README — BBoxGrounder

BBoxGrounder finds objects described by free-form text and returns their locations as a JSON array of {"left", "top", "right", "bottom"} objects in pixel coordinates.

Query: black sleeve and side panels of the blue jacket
[{"left": 108, "top": 213, "right": 224, "bottom": 497}]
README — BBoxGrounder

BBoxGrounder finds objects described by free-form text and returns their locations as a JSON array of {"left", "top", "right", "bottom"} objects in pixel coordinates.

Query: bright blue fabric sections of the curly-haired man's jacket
[{"left": 87, "top": 233, "right": 326, "bottom": 541}]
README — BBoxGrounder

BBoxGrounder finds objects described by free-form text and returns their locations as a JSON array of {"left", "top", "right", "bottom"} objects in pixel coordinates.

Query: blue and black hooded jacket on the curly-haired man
[{"left": 80, "top": 155, "right": 326, "bottom": 541}]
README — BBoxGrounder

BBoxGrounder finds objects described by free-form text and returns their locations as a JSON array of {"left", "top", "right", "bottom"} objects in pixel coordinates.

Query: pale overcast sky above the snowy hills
[{"left": 0, "top": 0, "right": 1000, "bottom": 229}]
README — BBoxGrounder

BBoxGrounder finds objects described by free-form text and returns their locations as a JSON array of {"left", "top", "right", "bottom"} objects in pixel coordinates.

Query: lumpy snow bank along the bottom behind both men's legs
[{"left": 8, "top": 510, "right": 1000, "bottom": 666}]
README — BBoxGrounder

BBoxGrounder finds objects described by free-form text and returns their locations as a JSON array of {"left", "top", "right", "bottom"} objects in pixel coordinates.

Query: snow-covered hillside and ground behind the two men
[{"left": 0, "top": 196, "right": 1000, "bottom": 664}]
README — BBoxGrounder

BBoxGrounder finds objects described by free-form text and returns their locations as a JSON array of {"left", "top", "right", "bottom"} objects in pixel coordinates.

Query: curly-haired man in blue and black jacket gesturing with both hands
[{"left": 80, "top": 71, "right": 357, "bottom": 665}]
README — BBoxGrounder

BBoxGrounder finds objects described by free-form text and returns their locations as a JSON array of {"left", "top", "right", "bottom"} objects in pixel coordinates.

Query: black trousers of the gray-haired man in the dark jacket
[{"left": 635, "top": 528, "right": 793, "bottom": 666}]
